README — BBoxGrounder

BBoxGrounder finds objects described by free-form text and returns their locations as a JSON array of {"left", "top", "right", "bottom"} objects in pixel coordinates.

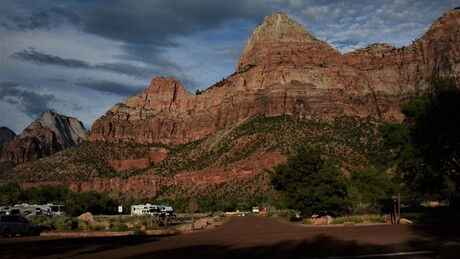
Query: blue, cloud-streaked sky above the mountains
[{"left": 0, "top": 0, "right": 460, "bottom": 134}]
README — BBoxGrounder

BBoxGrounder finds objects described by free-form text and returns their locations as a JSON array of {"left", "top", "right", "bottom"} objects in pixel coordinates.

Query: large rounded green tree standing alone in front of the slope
[{"left": 271, "top": 146, "right": 347, "bottom": 216}]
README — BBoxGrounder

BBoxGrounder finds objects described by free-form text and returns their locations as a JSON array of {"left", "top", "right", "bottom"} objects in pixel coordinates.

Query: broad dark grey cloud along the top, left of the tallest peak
[{"left": 84, "top": 0, "right": 268, "bottom": 45}]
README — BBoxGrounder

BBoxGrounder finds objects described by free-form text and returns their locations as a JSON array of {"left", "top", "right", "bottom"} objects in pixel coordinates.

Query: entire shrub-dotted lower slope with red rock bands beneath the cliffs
[{"left": 1, "top": 115, "right": 388, "bottom": 200}]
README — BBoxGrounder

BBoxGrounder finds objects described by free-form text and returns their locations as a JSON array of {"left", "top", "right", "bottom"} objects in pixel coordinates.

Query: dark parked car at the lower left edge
[{"left": 0, "top": 215, "right": 35, "bottom": 237}]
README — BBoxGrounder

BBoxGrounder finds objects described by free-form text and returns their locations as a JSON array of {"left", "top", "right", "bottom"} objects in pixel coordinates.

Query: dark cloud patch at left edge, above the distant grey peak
[{"left": 0, "top": 82, "right": 59, "bottom": 118}]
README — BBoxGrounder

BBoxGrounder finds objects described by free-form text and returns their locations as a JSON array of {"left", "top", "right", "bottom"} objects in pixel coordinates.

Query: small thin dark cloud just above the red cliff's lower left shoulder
[{"left": 76, "top": 80, "right": 142, "bottom": 96}]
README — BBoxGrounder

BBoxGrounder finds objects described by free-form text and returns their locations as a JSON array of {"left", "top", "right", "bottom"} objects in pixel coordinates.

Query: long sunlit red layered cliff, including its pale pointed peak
[{"left": 90, "top": 9, "right": 460, "bottom": 144}]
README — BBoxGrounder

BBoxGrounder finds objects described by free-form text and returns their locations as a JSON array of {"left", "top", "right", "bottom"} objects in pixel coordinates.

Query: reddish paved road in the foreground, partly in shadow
[{"left": 0, "top": 217, "right": 460, "bottom": 259}]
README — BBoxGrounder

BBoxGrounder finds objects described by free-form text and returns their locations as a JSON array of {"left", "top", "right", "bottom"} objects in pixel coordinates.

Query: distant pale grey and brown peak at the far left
[{"left": 0, "top": 111, "right": 88, "bottom": 165}]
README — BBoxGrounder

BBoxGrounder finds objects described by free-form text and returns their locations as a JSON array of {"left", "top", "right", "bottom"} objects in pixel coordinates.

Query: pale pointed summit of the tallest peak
[{"left": 236, "top": 13, "right": 332, "bottom": 72}]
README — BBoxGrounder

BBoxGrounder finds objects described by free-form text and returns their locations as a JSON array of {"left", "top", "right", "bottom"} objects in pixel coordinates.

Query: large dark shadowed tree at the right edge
[{"left": 380, "top": 77, "right": 460, "bottom": 205}]
